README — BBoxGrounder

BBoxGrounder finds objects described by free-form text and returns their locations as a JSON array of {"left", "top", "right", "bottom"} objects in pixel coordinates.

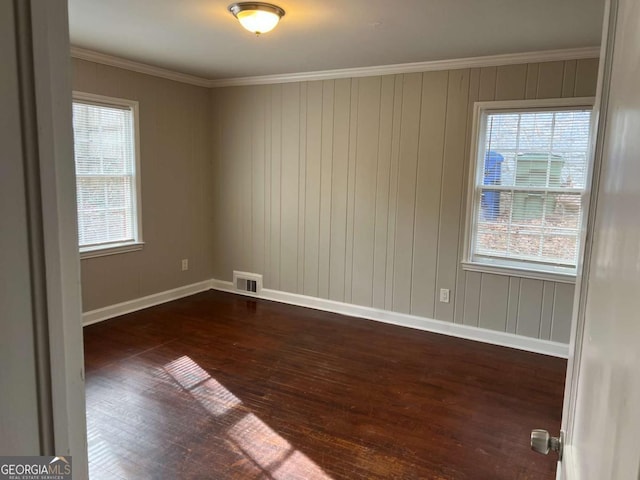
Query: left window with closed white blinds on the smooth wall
[{"left": 73, "top": 92, "right": 142, "bottom": 258}]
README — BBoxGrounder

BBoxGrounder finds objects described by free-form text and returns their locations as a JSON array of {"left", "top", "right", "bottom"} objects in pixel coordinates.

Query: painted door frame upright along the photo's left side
[{"left": 19, "top": 0, "right": 88, "bottom": 480}]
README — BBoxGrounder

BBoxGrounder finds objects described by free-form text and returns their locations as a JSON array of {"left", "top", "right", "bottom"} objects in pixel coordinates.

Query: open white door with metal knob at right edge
[{"left": 559, "top": 0, "right": 640, "bottom": 480}]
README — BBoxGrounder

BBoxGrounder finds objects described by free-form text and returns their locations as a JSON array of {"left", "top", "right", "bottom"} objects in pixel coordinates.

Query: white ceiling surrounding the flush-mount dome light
[{"left": 69, "top": 0, "right": 604, "bottom": 79}]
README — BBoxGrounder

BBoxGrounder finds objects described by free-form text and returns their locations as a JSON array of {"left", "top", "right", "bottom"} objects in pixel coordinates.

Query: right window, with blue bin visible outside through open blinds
[{"left": 463, "top": 99, "right": 592, "bottom": 281}]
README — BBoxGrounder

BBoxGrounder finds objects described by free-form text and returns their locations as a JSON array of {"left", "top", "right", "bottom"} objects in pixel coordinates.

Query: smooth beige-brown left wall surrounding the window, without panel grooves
[{"left": 73, "top": 59, "right": 213, "bottom": 312}]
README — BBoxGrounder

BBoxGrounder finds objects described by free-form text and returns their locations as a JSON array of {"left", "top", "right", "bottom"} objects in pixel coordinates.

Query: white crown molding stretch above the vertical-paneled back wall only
[{"left": 209, "top": 47, "right": 600, "bottom": 88}]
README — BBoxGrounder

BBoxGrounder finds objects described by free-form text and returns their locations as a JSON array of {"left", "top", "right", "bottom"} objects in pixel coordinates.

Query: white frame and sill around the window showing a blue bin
[{"left": 461, "top": 97, "right": 595, "bottom": 283}]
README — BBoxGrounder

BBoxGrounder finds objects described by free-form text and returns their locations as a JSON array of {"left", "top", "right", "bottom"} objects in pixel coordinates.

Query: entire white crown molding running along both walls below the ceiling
[{"left": 71, "top": 47, "right": 600, "bottom": 88}]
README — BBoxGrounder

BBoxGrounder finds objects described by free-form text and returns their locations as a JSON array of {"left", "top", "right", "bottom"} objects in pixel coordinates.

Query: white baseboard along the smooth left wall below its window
[{"left": 82, "top": 280, "right": 211, "bottom": 326}]
